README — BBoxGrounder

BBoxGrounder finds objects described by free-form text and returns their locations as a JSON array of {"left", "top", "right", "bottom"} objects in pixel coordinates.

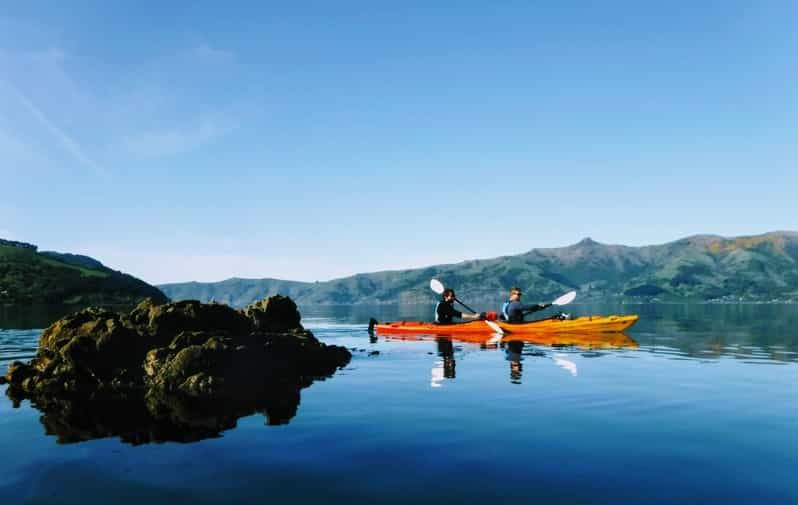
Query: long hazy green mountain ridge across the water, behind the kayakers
[{"left": 159, "top": 231, "right": 798, "bottom": 306}]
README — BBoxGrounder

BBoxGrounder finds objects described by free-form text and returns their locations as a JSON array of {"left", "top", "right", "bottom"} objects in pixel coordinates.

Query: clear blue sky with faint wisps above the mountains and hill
[{"left": 0, "top": 1, "right": 798, "bottom": 283}]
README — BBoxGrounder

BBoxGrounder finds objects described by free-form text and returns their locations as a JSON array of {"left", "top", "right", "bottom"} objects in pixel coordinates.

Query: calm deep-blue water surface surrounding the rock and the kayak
[{"left": 0, "top": 305, "right": 798, "bottom": 505}]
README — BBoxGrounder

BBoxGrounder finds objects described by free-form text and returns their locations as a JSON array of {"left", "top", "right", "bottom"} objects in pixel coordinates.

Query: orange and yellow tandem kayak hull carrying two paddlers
[{"left": 374, "top": 315, "right": 639, "bottom": 335}]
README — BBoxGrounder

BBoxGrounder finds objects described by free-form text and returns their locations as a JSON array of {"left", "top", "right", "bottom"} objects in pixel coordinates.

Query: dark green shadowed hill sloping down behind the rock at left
[{"left": 0, "top": 239, "right": 167, "bottom": 305}]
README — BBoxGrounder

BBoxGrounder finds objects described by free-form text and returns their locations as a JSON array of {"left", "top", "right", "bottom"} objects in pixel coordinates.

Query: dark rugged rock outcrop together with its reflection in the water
[{"left": 4, "top": 296, "right": 351, "bottom": 443}]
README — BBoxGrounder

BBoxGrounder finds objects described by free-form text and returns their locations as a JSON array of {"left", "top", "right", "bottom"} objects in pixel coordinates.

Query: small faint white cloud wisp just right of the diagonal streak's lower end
[{"left": 122, "top": 119, "right": 229, "bottom": 157}]
